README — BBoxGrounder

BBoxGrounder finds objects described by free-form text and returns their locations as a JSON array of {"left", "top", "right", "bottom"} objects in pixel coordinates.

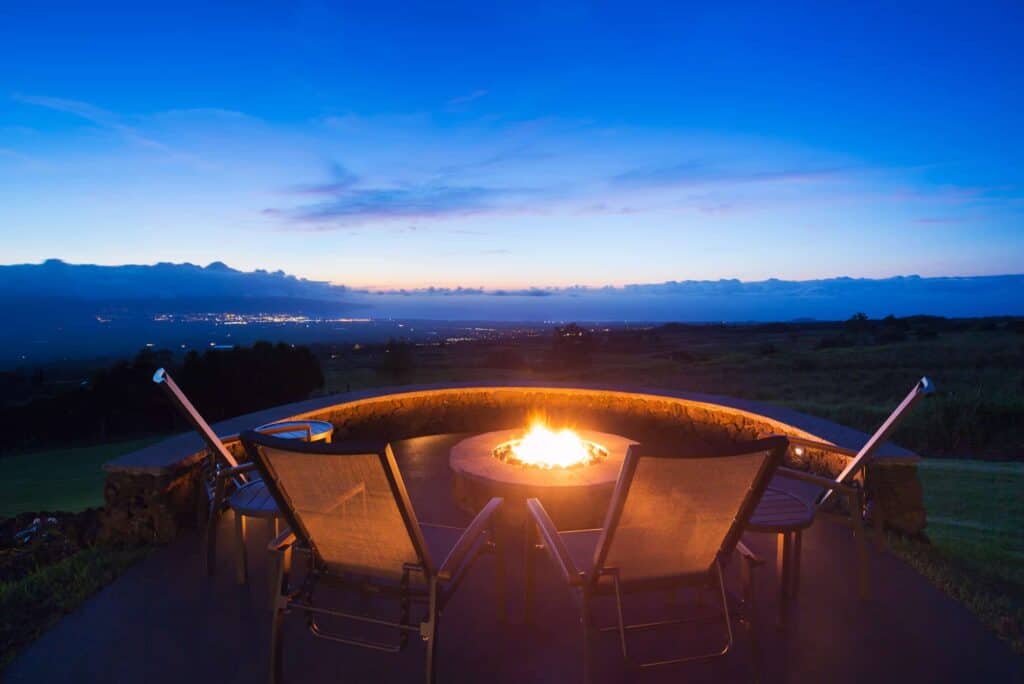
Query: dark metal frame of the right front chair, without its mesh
[{"left": 525, "top": 436, "right": 788, "bottom": 682}]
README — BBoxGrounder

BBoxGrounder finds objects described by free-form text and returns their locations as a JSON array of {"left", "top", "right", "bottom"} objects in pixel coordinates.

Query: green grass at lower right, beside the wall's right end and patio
[{"left": 892, "top": 459, "right": 1024, "bottom": 654}]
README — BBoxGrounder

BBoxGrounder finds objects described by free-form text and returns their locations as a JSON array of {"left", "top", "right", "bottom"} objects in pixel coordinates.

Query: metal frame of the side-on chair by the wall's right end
[{"left": 759, "top": 377, "right": 935, "bottom": 606}]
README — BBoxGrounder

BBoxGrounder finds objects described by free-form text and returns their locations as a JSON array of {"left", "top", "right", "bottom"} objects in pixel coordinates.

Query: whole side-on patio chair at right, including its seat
[{"left": 746, "top": 378, "right": 934, "bottom": 610}]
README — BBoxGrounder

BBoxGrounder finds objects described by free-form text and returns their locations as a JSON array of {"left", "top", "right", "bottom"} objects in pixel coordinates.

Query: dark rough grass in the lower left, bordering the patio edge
[{"left": 0, "top": 548, "right": 147, "bottom": 671}]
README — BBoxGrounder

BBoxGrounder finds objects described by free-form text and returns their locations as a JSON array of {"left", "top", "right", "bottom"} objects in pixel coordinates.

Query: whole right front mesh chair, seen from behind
[{"left": 526, "top": 437, "right": 787, "bottom": 682}]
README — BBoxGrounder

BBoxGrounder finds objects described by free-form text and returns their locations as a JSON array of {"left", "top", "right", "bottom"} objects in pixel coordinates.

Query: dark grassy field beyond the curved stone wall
[{"left": 323, "top": 326, "right": 1024, "bottom": 460}]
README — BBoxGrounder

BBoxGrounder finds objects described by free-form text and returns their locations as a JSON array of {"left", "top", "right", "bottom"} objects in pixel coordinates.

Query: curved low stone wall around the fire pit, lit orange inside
[{"left": 101, "top": 385, "right": 926, "bottom": 543}]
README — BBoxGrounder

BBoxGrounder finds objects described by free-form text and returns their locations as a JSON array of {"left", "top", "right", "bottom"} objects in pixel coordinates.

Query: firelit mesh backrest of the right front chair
[{"left": 590, "top": 436, "right": 788, "bottom": 582}]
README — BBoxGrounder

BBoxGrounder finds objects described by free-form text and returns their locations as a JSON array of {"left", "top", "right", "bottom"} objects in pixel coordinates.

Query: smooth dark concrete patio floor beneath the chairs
[{"left": 4, "top": 435, "right": 1024, "bottom": 684}]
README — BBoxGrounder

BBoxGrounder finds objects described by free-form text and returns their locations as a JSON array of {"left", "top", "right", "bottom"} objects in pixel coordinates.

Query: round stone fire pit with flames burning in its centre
[{"left": 449, "top": 423, "right": 634, "bottom": 528}]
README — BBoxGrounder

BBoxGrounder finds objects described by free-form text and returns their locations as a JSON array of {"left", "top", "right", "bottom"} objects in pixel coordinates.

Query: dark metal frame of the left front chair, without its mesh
[{"left": 241, "top": 430, "right": 505, "bottom": 684}]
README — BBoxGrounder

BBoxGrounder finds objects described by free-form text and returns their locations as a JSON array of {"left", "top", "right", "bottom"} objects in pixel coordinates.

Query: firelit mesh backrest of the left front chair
[{"left": 242, "top": 430, "right": 435, "bottom": 581}]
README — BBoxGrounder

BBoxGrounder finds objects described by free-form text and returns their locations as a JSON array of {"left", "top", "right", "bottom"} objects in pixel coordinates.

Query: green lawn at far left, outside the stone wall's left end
[{"left": 0, "top": 437, "right": 159, "bottom": 517}]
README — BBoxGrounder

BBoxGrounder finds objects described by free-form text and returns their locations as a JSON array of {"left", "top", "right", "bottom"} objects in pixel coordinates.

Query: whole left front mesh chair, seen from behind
[{"left": 242, "top": 431, "right": 505, "bottom": 682}]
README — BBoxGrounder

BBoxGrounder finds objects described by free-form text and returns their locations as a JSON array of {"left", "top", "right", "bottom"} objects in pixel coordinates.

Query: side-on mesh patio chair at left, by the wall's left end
[{"left": 153, "top": 369, "right": 330, "bottom": 584}]
